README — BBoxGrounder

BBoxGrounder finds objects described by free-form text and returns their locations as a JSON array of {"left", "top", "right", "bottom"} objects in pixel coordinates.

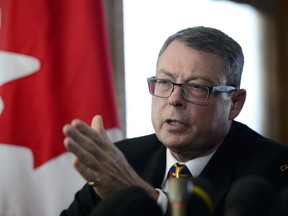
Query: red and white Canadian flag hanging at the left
[{"left": 0, "top": 0, "right": 122, "bottom": 216}]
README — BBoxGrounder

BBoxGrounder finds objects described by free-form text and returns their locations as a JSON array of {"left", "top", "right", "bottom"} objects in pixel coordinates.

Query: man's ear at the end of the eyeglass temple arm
[{"left": 229, "top": 89, "right": 246, "bottom": 120}]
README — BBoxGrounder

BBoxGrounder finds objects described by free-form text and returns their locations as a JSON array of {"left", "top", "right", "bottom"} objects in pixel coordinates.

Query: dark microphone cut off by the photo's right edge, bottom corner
[{"left": 270, "top": 188, "right": 288, "bottom": 216}]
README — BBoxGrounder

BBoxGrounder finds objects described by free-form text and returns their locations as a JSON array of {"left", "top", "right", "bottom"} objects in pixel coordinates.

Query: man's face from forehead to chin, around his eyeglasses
[{"left": 152, "top": 41, "right": 232, "bottom": 160}]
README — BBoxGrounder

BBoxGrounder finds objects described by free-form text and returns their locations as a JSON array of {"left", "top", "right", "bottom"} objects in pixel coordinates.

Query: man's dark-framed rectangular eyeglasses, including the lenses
[{"left": 147, "top": 77, "right": 237, "bottom": 103}]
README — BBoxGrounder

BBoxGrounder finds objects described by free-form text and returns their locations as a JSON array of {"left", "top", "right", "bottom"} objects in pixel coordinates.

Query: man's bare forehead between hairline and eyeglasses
[{"left": 156, "top": 41, "right": 226, "bottom": 84}]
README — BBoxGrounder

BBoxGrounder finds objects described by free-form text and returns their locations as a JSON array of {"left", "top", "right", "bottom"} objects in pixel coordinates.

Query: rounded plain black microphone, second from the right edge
[{"left": 223, "top": 175, "right": 275, "bottom": 216}]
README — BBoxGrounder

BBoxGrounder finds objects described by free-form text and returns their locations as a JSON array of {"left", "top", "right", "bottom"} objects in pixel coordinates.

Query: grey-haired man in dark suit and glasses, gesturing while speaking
[{"left": 62, "top": 27, "right": 288, "bottom": 215}]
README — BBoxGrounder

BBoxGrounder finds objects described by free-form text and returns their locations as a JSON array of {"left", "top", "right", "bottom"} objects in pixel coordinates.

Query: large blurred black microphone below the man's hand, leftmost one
[{"left": 91, "top": 186, "right": 162, "bottom": 216}]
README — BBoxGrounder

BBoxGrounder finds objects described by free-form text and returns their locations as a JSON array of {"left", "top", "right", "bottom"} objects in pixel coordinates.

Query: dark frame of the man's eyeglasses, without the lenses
[{"left": 147, "top": 76, "right": 238, "bottom": 103}]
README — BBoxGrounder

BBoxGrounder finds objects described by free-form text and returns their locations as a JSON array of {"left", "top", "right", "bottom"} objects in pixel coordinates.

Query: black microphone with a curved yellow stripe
[{"left": 188, "top": 177, "right": 214, "bottom": 216}]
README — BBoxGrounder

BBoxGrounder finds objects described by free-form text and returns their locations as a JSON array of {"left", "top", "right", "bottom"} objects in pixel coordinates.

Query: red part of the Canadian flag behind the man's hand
[{"left": 0, "top": 0, "right": 119, "bottom": 167}]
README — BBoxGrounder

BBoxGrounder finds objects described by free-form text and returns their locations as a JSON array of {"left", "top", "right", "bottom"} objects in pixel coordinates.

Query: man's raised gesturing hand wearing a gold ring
[{"left": 63, "top": 115, "right": 158, "bottom": 199}]
